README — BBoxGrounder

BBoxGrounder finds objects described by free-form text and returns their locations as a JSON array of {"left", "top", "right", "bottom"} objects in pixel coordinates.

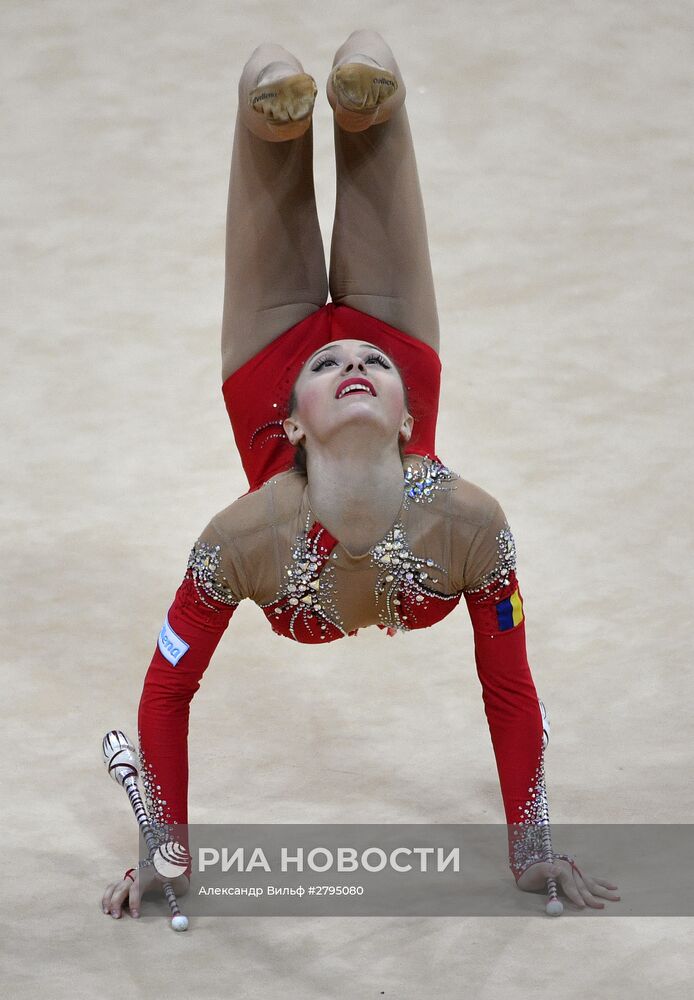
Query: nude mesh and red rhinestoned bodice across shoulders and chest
[{"left": 188, "top": 456, "right": 506, "bottom": 642}]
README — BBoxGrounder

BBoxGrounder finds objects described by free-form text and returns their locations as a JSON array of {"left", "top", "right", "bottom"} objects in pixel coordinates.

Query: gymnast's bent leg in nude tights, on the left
[{"left": 222, "top": 43, "right": 328, "bottom": 381}]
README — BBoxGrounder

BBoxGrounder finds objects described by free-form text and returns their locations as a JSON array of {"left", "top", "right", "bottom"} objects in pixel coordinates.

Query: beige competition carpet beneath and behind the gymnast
[{"left": 0, "top": 0, "right": 694, "bottom": 1000}]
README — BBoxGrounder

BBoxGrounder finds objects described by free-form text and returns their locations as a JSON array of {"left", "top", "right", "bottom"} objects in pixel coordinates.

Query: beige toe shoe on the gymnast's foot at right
[{"left": 326, "top": 53, "right": 402, "bottom": 132}]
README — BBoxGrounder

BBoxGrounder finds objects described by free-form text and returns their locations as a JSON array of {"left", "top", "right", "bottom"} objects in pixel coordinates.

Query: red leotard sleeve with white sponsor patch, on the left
[{"left": 138, "top": 543, "right": 238, "bottom": 875}]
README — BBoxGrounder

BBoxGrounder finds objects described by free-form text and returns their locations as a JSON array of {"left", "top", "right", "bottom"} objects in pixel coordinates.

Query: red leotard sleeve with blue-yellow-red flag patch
[{"left": 463, "top": 507, "right": 548, "bottom": 881}]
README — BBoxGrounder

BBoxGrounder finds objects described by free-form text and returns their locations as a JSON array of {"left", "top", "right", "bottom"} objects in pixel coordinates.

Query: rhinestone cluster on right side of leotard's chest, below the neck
[{"left": 369, "top": 521, "right": 460, "bottom": 632}]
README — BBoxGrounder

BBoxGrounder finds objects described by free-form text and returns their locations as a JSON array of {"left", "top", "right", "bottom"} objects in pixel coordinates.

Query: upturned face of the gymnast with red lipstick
[{"left": 284, "top": 340, "right": 413, "bottom": 449}]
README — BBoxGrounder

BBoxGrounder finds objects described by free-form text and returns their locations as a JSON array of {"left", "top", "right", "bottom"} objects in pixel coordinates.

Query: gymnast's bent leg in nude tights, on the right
[{"left": 327, "top": 30, "right": 439, "bottom": 351}]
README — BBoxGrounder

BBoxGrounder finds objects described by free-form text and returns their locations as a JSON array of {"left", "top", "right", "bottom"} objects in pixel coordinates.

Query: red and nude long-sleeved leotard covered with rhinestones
[{"left": 138, "top": 303, "right": 546, "bottom": 879}]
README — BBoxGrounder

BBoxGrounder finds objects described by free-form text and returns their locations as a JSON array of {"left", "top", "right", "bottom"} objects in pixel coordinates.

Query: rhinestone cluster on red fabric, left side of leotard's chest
[{"left": 260, "top": 509, "right": 347, "bottom": 639}]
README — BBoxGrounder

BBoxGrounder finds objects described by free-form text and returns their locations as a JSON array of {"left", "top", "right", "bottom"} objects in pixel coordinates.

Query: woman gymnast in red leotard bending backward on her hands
[{"left": 102, "top": 30, "right": 619, "bottom": 917}]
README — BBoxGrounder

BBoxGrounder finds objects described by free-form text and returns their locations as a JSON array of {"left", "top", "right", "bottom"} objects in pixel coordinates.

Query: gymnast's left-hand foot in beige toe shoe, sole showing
[{"left": 247, "top": 60, "right": 318, "bottom": 142}]
